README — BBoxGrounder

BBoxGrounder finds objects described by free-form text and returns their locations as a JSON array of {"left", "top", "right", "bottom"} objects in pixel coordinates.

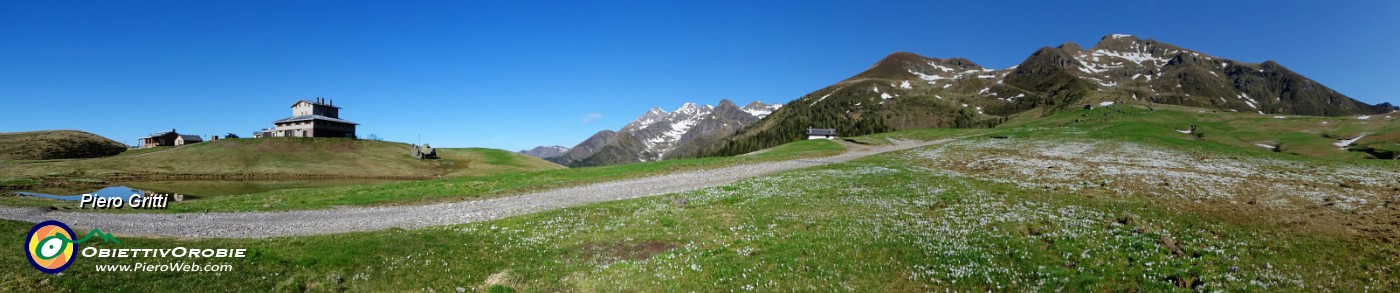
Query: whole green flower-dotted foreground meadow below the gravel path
[{"left": 0, "top": 131, "right": 1400, "bottom": 292}]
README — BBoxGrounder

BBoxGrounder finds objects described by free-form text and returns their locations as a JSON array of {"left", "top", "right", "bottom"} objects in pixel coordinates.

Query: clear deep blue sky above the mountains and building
[{"left": 0, "top": 0, "right": 1400, "bottom": 150}]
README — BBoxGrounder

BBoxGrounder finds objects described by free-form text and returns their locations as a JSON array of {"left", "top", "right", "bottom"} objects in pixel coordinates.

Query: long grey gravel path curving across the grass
[{"left": 0, "top": 139, "right": 952, "bottom": 238}]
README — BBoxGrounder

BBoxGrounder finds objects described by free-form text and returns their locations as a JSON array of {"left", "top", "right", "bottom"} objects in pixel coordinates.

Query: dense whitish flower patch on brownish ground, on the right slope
[{"left": 913, "top": 139, "right": 1400, "bottom": 214}]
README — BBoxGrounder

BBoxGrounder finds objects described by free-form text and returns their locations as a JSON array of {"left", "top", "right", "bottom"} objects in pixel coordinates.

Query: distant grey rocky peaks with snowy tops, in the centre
[{"left": 536, "top": 100, "right": 783, "bottom": 167}]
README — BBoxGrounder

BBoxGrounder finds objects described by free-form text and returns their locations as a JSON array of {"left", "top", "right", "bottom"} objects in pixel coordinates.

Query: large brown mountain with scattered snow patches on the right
[{"left": 703, "top": 34, "right": 1396, "bottom": 156}]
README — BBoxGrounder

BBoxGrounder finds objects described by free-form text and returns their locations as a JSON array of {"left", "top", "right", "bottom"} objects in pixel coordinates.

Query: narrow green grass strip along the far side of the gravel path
[{"left": 0, "top": 140, "right": 846, "bottom": 213}]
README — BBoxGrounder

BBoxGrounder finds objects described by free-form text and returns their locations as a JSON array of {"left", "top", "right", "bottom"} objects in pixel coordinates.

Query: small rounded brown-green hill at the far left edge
[{"left": 0, "top": 130, "right": 127, "bottom": 161}]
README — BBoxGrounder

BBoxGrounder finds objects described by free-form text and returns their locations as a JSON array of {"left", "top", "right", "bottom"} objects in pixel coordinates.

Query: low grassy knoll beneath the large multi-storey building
[{"left": 0, "top": 137, "right": 563, "bottom": 178}]
